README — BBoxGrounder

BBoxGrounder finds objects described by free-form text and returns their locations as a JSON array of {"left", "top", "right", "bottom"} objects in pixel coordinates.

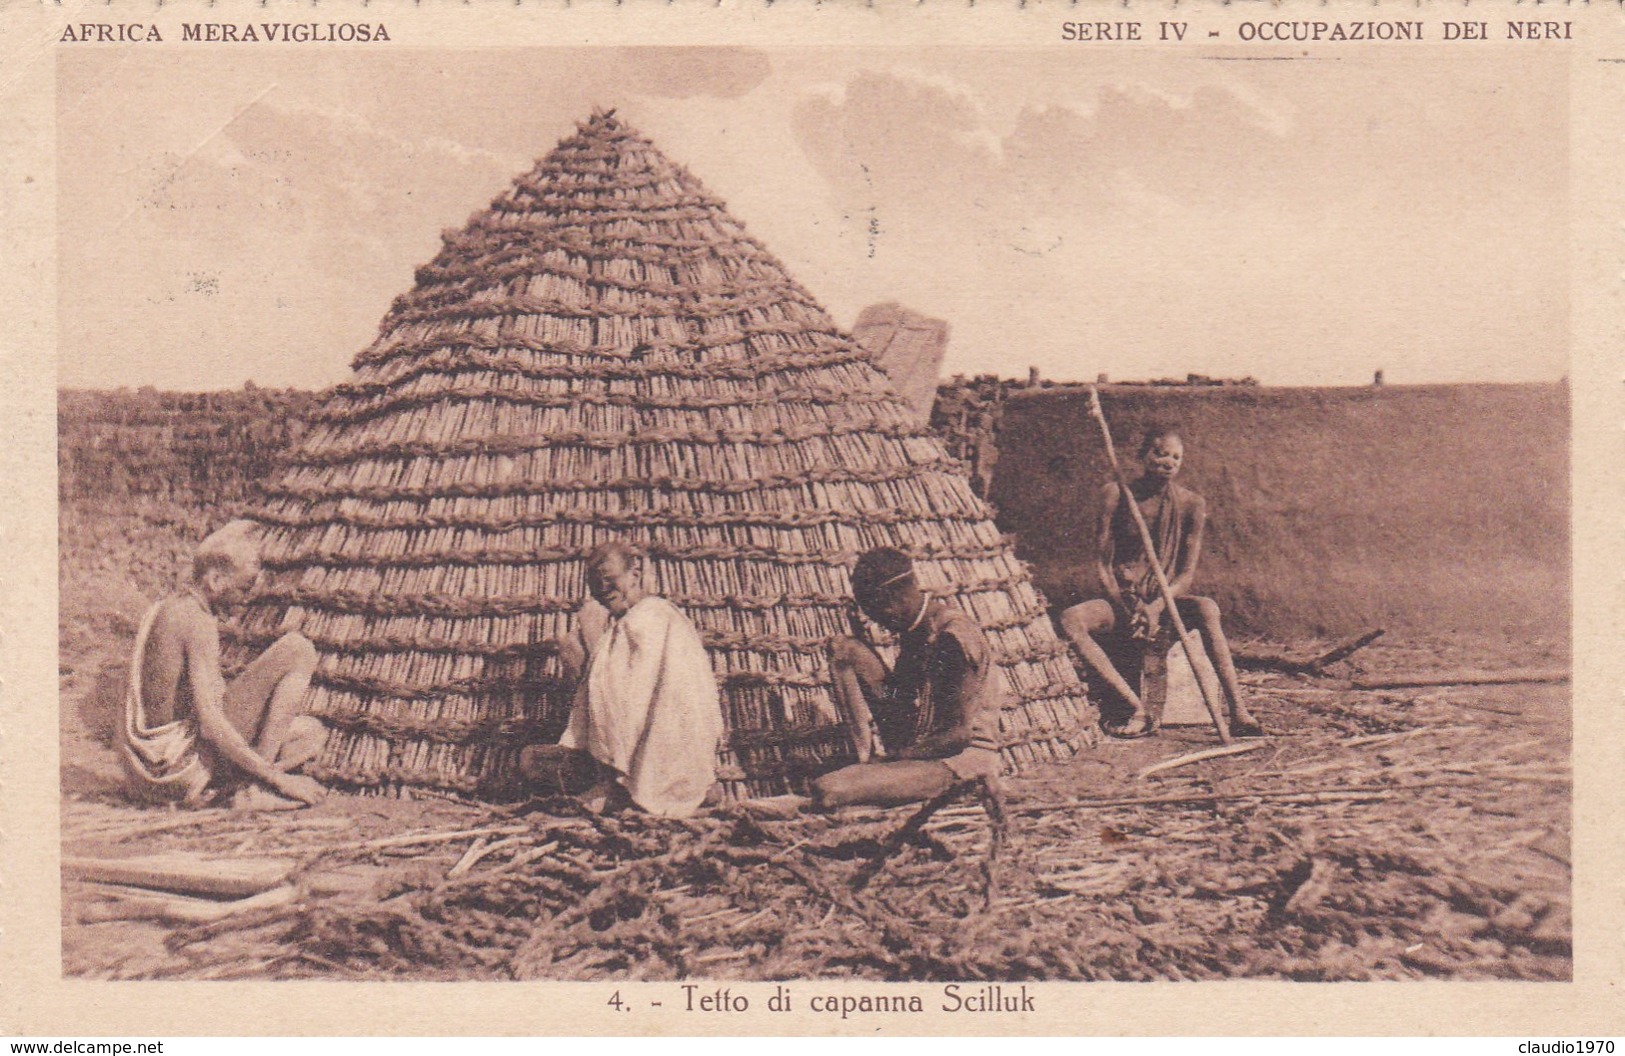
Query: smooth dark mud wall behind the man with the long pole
[{"left": 990, "top": 385, "right": 1570, "bottom": 637}]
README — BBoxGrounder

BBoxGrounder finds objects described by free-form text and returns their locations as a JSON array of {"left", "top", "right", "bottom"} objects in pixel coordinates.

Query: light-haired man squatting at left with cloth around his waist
[{"left": 120, "top": 522, "right": 327, "bottom": 807}]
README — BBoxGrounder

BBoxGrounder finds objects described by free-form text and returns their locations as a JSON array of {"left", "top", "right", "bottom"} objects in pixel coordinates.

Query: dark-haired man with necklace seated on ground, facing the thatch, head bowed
[{"left": 813, "top": 547, "right": 1008, "bottom": 807}]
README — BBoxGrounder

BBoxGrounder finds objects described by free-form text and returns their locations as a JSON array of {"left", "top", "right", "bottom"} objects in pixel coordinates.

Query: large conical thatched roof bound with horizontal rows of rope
[{"left": 242, "top": 114, "right": 1087, "bottom": 798}]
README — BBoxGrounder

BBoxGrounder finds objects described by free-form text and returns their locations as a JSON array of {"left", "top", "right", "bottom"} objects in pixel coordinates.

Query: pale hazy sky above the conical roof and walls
[{"left": 57, "top": 47, "right": 1570, "bottom": 390}]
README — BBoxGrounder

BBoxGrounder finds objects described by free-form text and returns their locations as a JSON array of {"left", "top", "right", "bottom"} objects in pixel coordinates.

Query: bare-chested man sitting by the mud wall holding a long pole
[{"left": 1061, "top": 426, "right": 1263, "bottom": 738}]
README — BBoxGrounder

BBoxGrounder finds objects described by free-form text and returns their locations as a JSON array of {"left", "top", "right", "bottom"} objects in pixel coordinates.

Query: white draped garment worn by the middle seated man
[{"left": 559, "top": 595, "right": 722, "bottom": 817}]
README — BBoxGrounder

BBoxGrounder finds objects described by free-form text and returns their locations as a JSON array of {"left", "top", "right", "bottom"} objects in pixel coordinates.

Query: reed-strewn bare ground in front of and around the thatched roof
[{"left": 60, "top": 510, "right": 1571, "bottom": 980}]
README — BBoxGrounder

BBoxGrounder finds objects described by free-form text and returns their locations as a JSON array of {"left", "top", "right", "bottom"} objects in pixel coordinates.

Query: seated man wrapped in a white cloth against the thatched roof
[{"left": 520, "top": 543, "right": 722, "bottom": 817}]
